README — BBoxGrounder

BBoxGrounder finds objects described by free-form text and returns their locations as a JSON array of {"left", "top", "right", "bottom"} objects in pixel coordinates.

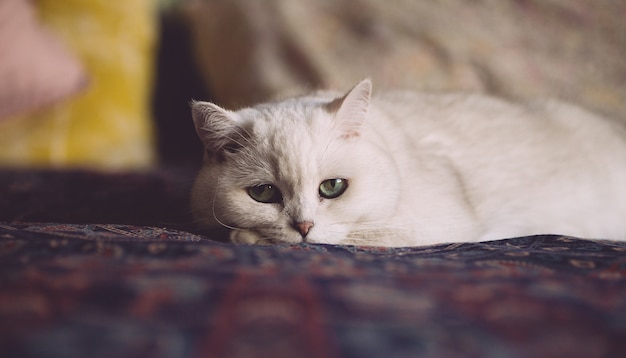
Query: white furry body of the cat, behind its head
[{"left": 370, "top": 92, "right": 626, "bottom": 240}]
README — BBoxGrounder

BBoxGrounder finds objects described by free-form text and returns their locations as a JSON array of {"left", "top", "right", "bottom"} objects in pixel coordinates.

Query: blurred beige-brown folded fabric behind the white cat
[{"left": 185, "top": 0, "right": 626, "bottom": 118}]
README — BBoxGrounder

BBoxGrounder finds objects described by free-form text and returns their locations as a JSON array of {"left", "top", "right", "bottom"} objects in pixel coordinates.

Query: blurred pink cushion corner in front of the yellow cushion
[{"left": 0, "top": 0, "right": 87, "bottom": 120}]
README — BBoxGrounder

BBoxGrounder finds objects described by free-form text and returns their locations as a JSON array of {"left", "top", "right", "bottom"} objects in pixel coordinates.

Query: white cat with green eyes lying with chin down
[{"left": 191, "top": 80, "right": 626, "bottom": 246}]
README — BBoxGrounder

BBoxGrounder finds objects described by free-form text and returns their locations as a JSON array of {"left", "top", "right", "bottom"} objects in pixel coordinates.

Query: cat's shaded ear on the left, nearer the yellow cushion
[{"left": 191, "top": 101, "right": 241, "bottom": 154}]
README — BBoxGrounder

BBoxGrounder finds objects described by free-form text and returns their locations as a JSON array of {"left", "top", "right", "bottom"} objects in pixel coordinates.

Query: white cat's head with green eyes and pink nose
[{"left": 192, "top": 80, "right": 399, "bottom": 243}]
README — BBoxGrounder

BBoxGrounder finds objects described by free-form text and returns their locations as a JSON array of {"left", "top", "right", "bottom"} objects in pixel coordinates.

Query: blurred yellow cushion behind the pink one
[{"left": 0, "top": 0, "right": 156, "bottom": 169}]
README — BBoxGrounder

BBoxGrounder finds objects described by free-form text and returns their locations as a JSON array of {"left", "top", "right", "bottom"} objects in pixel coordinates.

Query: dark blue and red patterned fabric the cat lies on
[{"left": 0, "top": 221, "right": 626, "bottom": 357}]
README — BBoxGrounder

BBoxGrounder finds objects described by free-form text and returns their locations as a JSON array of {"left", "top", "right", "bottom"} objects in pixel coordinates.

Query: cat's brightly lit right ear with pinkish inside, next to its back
[{"left": 328, "top": 79, "right": 372, "bottom": 138}]
